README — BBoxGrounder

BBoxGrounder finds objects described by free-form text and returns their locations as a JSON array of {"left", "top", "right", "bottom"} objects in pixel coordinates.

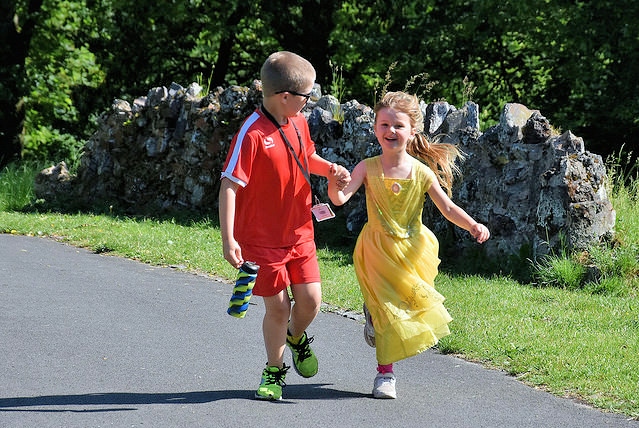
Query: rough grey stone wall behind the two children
[{"left": 36, "top": 81, "right": 615, "bottom": 257}]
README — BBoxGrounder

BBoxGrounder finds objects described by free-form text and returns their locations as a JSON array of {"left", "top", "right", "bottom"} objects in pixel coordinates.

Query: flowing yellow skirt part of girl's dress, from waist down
[{"left": 353, "top": 224, "right": 452, "bottom": 364}]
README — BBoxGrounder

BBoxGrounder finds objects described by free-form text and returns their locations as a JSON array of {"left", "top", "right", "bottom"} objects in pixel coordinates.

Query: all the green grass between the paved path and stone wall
[{"left": 0, "top": 160, "right": 639, "bottom": 418}]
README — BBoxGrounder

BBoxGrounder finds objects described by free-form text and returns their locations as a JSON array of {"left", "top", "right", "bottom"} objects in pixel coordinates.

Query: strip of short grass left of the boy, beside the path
[{"left": 0, "top": 212, "right": 235, "bottom": 278}]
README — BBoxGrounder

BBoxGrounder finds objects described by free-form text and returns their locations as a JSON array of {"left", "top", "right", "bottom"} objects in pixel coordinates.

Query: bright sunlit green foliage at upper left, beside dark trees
[{"left": 23, "top": 0, "right": 105, "bottom": 159}]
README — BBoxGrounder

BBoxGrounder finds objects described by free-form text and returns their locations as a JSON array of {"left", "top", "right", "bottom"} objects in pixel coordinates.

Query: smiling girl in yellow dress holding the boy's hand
[{"left": 329, "top": 92, "right": 490, "bottom": 398}]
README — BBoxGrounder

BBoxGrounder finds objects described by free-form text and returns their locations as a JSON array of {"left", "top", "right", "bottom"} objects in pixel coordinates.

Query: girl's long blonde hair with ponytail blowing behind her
[{"left": 374, "top": 92, "right": 464, "bottom": 196}]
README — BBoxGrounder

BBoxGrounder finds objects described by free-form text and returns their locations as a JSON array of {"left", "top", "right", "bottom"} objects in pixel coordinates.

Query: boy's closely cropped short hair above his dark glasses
[{"left": 260, "top": 51, "right": 315, "bottom": 97}]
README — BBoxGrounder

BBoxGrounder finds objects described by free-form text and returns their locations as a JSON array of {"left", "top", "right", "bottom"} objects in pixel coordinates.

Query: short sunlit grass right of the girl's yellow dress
[{"left": 438, "top": 276, "right": 639, "bottom": 417}]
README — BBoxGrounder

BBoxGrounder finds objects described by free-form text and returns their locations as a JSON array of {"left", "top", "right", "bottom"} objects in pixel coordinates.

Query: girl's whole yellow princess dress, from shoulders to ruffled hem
[{"left": 353, "top": 156, "right": 452, "bottom": 364}]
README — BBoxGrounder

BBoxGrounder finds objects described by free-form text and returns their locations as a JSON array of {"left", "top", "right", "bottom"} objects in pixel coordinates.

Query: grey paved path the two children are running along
[{"left": 0, "top": 235, "right": 639, "bottom": 428}]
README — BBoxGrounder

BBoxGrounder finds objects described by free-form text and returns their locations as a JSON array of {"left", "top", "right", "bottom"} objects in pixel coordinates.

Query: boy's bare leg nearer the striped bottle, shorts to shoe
[{"left": 262, "top": 290, "right": 292, "bottom": 367}]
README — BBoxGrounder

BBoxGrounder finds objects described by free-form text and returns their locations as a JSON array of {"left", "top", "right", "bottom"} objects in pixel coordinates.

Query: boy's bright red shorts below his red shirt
[{"left": 241, "top": 241, "right": 320, "bottom": 297}]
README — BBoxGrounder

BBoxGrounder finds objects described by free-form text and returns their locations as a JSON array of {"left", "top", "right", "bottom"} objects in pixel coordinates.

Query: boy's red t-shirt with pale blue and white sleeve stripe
[{"left": 222, "top": 110, "right": 315, "bottom": 248}]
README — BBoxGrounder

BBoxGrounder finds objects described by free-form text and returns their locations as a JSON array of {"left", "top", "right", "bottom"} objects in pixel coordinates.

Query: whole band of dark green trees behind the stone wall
[{"left": 0, "top": 0, "right": 639, "bottom": 167}]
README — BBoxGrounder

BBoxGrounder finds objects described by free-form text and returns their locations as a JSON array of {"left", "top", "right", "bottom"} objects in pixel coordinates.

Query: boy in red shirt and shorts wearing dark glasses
[{"left": 219, "top": 51, "right": 350, "bottom": 400}]
